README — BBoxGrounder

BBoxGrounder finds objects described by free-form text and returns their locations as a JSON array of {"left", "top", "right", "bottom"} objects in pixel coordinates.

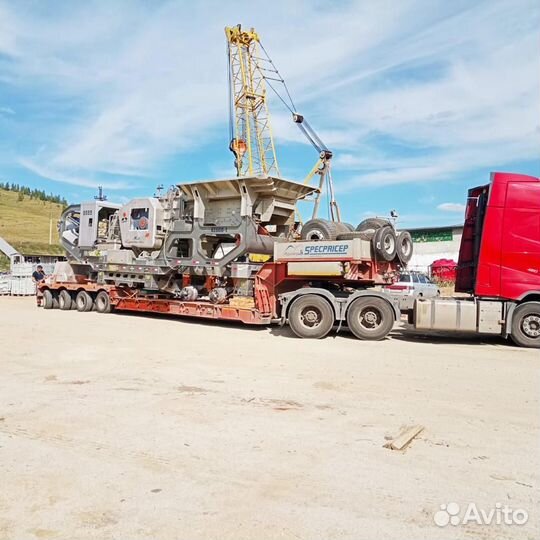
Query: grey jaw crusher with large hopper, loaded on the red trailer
[{"left": 59, "top": 176, "right": 318, "bottom": 302}]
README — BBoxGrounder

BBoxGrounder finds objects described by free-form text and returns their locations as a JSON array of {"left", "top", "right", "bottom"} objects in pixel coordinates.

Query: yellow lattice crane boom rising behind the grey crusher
[{"left": 225, "top": 25, "right": 279, "bottom": 176}]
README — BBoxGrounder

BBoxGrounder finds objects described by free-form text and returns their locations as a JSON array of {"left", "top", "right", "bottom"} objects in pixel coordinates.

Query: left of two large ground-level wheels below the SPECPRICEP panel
[{"left": 288, "top": 294, "right": 335, "bottom": 339}]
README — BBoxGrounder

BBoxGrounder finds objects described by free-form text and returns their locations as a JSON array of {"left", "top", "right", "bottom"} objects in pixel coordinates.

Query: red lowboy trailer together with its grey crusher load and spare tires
[{"left": 39, "top": 176, "right": 412, "bottom": 339}]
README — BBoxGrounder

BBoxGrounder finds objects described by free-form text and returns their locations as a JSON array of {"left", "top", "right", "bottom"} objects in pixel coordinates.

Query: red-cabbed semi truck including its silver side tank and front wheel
[{"left": 410, "top": 172, "right": 540, "bottom": 348}]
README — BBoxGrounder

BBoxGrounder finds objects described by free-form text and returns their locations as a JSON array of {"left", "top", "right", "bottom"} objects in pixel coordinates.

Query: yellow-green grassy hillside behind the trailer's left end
[{"left": 0, "top": 189, "right": 64, "bottom": 266}]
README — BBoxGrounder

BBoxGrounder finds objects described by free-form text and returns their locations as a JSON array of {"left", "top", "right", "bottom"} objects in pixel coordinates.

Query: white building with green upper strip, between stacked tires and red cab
[{"left": 407, "top": 225, "right": 463, "bottom": 272}]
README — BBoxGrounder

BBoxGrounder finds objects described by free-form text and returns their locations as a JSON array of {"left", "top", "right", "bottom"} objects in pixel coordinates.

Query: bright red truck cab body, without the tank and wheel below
[{"left": 456, "top": 172, "right": 540, "bottom": 301}]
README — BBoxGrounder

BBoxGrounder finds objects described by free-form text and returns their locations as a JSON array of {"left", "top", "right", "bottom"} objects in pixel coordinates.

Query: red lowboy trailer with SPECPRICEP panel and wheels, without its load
[{"left": 39, "top": 237, "right": 400, "bottom": 340}]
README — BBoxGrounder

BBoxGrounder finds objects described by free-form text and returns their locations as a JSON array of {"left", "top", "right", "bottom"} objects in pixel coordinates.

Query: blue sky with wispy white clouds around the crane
[{"left": 0, "top": 0, "right": 540, "bottom": 227}]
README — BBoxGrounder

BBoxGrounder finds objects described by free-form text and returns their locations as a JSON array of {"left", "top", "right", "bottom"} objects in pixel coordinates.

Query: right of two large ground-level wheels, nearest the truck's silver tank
[{"left": 347, "top": 296, "right": 395, "bottom": 341}]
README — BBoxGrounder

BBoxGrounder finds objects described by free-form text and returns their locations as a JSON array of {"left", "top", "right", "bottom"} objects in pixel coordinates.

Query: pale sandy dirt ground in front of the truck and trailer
[{"left": 0, "top": 297, "right": 540, "bottom": 540}]
